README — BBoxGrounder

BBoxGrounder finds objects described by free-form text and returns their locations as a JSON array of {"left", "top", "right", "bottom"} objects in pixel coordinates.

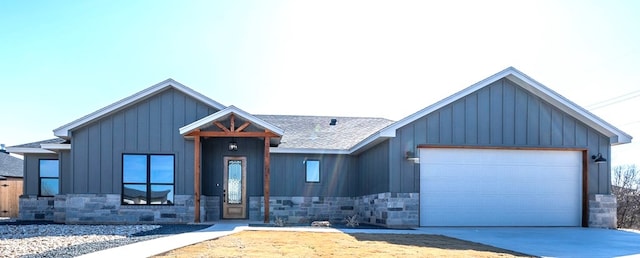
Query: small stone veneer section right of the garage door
[{"left": 589, "top": 194, "right": 618, "bottom": 228}]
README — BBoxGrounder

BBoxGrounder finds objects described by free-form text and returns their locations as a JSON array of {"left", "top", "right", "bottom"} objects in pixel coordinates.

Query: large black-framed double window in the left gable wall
[{"left": 122, "top": 154, "right": 175, "bottom": 205}]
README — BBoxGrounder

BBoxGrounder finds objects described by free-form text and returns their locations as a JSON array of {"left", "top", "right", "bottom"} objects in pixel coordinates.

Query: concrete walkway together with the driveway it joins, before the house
[{"left": 80, "top": 221, "right": 640, "bottom": 257}]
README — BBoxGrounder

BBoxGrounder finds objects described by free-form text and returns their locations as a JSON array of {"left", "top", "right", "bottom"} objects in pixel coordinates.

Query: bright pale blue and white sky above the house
[{"left": 0, "top": 0, "right": 640, "bottom": 165}]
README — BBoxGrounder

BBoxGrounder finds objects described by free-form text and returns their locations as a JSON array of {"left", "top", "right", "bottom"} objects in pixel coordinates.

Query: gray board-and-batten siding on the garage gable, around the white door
[{"left": 384, "top": 78, "right": 611, "bottom": 194}]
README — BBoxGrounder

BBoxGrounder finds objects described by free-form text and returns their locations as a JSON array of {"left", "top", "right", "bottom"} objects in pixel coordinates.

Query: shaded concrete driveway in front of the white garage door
[{"left": 418, "top": 227, "right": 640, "bottom": 257}]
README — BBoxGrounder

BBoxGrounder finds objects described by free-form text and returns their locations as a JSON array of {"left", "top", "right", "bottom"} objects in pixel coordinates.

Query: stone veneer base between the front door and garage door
[{"left": 249, "top": 192, "right": 420, "bottom": 228}]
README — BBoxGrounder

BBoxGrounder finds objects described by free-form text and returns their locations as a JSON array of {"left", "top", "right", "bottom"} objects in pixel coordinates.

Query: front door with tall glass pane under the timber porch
[{"left": 222, "top": 157, "right": 247, "bottom": 219}]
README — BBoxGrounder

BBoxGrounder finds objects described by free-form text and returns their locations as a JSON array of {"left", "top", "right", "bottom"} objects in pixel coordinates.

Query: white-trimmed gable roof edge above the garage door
[{"left": 353, "top": 67, "right": 633, "bottom": 152}]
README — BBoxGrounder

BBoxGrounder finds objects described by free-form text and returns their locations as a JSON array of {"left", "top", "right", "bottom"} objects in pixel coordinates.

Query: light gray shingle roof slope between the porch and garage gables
[{"left": 256, "top": 115, "right": 393, "bottom": 150}]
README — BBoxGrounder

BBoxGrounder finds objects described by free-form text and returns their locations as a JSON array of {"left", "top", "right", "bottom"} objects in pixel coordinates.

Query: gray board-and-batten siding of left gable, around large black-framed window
[{"left": 66, "top": 88, "right": 219, "bottom": 194}]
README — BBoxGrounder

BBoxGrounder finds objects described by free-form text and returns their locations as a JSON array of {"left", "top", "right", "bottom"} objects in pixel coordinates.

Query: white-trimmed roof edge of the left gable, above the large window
[{"left": 53, "top": 79, "right": 226, "bottom": 138}]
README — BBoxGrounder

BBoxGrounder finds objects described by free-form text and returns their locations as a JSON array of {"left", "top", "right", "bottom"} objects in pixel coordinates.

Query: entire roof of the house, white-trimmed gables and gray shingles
[{"left": 17, "top": 67, "right": 632, "bottom": 157}]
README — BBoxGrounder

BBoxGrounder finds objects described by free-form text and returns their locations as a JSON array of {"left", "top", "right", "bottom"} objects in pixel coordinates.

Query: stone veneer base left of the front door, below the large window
[{"left": 20, "top": 194, "right": 209, "bottom": 224}]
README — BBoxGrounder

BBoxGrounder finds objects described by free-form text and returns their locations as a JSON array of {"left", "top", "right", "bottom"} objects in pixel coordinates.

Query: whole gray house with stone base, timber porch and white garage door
[{"left": 8, "top": 67, "right": 632, "bottom": 227}]
